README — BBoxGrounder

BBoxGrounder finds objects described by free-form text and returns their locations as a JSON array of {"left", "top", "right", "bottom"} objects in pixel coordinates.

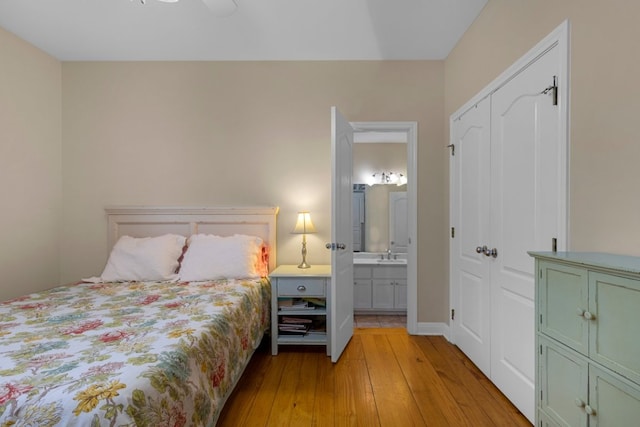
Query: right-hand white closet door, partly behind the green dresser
[{"left": 489, "top": 46, "right": 563, "bottom": 420}]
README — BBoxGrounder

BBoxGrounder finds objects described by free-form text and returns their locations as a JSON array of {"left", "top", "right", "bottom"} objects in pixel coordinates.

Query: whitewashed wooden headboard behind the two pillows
[{"left": 105, "top": 206, "right": 278, "bottom": 271}]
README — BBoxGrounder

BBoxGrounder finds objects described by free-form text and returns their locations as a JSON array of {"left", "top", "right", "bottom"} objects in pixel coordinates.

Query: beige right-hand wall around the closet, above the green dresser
[{"left": 441, "top": 0, "right": 640, "bottom": 318}]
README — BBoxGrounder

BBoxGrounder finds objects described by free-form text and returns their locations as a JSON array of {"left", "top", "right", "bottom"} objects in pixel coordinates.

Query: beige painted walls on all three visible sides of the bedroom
[{"left": 7, "top": 0, "right": 640, "bottom": 322}]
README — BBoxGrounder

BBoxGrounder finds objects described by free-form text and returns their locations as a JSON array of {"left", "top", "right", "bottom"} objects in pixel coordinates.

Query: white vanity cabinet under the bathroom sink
[{"left": 353, "top": 264, "right": 407, "bottom": 313}]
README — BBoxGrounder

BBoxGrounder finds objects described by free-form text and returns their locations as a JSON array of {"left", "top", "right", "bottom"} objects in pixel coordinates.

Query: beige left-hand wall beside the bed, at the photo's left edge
[{"left": 0, "top": 28, "right": 62, "bottom": 300}]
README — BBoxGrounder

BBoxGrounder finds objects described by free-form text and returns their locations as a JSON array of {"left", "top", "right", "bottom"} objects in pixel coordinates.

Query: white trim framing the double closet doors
[{"left": 448, "top": 19, "right": 571, "bottom": 343}]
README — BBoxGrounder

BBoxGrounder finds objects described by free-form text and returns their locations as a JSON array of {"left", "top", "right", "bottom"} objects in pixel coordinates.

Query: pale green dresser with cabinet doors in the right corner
[{"left": 530, "top": 252, "right": 640, "bottom": 427}]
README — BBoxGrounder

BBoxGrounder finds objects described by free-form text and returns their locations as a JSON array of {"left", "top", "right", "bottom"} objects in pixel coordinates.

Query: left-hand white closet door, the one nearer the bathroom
[{"left": 451, "top": 98, "right": 491, "bottom": 377}]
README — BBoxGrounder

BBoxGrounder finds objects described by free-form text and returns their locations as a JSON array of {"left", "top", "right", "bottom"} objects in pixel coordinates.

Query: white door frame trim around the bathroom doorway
[{"left": 351, "top": 122, "right": 418, "bottom": 335}]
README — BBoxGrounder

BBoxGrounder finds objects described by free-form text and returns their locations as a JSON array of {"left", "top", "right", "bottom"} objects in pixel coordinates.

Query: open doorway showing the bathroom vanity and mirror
[{"left": 351, "top": 122, "right": 417, "bottom": 333}]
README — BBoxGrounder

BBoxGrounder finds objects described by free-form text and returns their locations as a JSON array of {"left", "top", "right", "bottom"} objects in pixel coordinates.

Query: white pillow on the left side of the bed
[{"left": 100, "top": 234, "right": 186, "bottom": 282}]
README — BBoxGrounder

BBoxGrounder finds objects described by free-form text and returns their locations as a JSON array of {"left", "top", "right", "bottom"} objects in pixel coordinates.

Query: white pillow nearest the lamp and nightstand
[{"left": 180, "top": 234, "right": 262, "bottom": 282}]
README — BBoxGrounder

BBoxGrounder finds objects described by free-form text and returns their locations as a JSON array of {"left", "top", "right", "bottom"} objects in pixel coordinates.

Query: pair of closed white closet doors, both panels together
[{"left": 450, "top": 21, "right": 569, "bottom": 422}]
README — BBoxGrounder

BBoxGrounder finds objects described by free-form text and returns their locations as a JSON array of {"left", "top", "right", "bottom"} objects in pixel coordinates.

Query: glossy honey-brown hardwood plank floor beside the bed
[{"left": 217, "top": 328, "right": 531, "bottom": 427}]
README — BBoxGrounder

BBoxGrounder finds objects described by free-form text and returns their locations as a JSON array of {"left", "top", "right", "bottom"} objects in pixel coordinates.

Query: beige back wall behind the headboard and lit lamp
[{"left": 62, "top": 61, "right": 447, "bottom": 321}]
